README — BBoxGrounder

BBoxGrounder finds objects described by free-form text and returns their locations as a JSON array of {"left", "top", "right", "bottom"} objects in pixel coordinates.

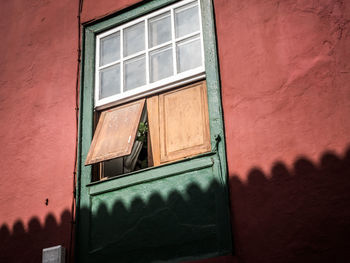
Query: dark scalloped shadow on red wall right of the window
[{"left": 230, "top": 148, "right": 350, "bottom": 263}]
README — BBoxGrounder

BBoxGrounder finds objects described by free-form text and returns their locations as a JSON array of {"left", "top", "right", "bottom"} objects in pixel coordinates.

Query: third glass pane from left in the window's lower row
[{"left": 150, "top": 46, "right": 173, "bottom": 82}]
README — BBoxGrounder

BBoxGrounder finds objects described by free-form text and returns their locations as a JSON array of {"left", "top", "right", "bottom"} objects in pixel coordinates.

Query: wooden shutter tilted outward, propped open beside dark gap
[{"left": 85, "top": 99, "right": 145, "bottom": 165}]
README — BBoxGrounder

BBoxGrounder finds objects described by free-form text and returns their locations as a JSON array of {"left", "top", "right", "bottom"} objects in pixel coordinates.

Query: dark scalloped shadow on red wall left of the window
[{"left": 0, "top": 210, "right": 73, "bottom": 263}]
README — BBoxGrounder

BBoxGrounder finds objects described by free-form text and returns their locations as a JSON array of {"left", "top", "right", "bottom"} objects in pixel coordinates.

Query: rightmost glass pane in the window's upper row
[{"left": 175, "top": 3, "right": 199, "bottom": 37}]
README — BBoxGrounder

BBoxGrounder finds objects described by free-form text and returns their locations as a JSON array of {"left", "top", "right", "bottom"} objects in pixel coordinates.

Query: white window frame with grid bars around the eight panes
[{"left": 95, "top": 0, "right": 205, "bottom": 110}]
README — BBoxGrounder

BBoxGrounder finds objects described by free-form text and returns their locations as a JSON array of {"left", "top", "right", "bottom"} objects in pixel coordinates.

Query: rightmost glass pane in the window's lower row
[{"left": 176, "top": 38, "right": 202, "bottom": 72}]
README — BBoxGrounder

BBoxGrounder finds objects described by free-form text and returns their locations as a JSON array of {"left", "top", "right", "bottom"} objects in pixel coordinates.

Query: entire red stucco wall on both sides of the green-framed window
[{"left": 0, "top": 0, "right": 350, "bottom": 263}]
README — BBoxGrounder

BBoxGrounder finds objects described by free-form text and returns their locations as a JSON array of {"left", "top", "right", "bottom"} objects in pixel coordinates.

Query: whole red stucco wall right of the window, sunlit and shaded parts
[{"left": 213, "top": 0, "right": 350, "bottom": 263}]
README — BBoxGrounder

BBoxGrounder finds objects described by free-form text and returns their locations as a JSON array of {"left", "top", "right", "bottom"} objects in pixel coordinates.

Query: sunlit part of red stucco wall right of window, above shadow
[{"left": 215, "top": 0, "right": 350, "bottom": 180}]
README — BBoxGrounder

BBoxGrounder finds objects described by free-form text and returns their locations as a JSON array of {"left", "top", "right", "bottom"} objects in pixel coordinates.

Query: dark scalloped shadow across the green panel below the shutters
[{"left": 78, "top": 175, "right": 231, "bottom": 262}]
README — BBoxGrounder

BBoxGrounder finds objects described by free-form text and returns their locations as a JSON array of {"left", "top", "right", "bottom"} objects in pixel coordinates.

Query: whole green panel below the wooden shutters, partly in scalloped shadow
[{"left": 83, "top": 160, "right": 228, "bottom": 262}]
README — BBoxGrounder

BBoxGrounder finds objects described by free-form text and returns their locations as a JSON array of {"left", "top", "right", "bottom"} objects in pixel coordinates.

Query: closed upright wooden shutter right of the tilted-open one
[{"left": 147, "top": 81, "right": 211, "bottom": 166}]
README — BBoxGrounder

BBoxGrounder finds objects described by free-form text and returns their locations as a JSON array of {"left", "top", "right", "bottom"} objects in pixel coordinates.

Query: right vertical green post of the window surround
[{"left": 200, "top": 0, "right": 232, "bottom": 251}]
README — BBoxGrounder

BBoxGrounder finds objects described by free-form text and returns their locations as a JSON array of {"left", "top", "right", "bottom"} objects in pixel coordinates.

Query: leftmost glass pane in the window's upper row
[{"left": 100, "top": 32, "right": 120, "bottom": 66}]
